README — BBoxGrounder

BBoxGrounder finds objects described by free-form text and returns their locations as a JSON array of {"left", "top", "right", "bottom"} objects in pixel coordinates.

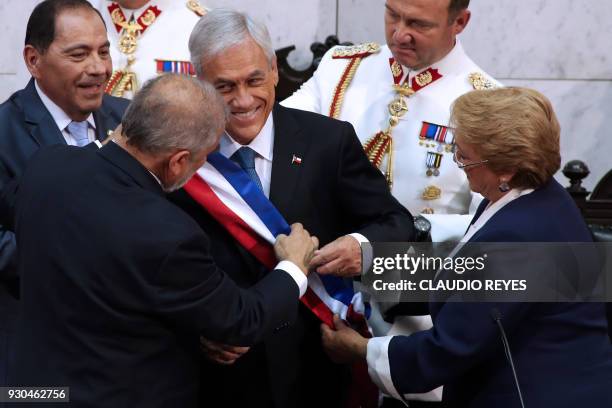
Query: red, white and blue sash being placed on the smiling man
[{"left": 185, "top": 152, "right": 370, "bottom": 331}]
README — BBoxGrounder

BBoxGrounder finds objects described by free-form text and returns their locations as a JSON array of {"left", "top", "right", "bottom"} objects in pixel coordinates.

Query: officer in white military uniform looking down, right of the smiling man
[{"left": 282, "top": 0, "right": 497, "bottom": 407}]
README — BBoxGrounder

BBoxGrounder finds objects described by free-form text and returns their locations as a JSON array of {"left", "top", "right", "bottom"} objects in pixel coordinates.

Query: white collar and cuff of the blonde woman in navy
[{"left": 366, "top": 189, "right": 533, "bottom": 399}]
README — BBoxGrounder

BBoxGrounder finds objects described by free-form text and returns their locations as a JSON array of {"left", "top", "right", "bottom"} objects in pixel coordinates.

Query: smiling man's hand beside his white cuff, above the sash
[{"left": 310, "top": 235, "right": 361, "bottom": 277}]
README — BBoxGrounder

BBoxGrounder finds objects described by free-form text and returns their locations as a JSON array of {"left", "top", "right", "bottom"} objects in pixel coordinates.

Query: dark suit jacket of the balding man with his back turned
[{"left": 4, "top": 143, "right": 298, "bottom": 407}]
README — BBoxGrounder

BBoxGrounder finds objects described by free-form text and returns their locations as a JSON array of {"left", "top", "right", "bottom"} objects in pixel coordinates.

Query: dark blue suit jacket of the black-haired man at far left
[{"left": 0, "top": 79, "right": 129, "bottom": 384}]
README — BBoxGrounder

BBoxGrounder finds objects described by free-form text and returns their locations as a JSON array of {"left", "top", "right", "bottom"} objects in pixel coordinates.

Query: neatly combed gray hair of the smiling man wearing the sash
[{"left": 189, "top": 8, "right": 276, "bottom": 76}]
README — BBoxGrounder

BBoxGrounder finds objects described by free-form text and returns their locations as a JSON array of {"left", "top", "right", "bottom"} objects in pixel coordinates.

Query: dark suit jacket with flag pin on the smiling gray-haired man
[{"left": 171, "top": 105, "right": 413, "bottom": 408}]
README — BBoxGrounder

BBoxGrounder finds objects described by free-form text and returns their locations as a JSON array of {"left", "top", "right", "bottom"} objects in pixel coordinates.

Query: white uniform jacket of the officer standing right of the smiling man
[{"left": 282, "top": 42, "right": 494, "bottom": 242}]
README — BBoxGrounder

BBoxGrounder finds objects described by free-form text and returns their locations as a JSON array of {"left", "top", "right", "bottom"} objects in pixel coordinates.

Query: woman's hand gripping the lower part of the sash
[{"left": 321, "top": 315, "right": 368, "bottom": 364}]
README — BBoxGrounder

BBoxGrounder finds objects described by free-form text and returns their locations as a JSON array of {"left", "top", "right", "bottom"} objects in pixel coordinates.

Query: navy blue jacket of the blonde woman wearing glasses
[{"left": 389, "top": 180, "right": 612, "bottom": 408}]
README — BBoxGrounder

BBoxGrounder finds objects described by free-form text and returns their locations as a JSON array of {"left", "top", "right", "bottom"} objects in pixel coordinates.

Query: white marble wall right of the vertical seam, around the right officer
[{"left": 338, "top": 0, "right": 612, "bottom": 189}]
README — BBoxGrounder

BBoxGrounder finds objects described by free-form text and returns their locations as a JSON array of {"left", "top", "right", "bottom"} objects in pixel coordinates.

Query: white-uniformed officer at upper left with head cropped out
[{"left": 97, "top": 0, "right": 206, "bottom": 98}]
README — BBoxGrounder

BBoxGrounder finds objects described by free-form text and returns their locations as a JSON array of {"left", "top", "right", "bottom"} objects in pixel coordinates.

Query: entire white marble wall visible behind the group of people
[{"left": 0, "top": 0, "right": 612, "bottom": 188}]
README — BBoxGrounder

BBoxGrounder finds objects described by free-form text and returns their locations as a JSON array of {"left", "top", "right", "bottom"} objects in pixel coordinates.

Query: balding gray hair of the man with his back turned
[{"left": 121, "top": 74, "right": 227, "bottom": 154}]
